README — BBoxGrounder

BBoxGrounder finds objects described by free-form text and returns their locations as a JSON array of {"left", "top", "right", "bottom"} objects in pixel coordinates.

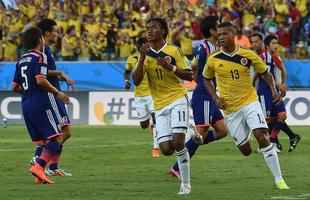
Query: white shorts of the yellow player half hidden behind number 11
[{"left": 133, "top": 96, "right": 155, "bottom": 122}]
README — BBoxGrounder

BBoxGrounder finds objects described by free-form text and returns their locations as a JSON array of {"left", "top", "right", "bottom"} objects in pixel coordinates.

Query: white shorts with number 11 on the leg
[{"left": 155, "top": 96, "right": 189, "bottom": 144}]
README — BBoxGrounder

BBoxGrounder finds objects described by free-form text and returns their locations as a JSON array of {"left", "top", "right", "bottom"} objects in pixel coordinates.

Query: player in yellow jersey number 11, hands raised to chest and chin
[{"left": 133, "top": 18, "right": 193, "bottom": 195}]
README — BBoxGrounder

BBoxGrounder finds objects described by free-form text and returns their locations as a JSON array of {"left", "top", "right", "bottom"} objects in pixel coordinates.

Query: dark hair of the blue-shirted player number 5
[{"left": 22, "top": 27, "right": 42, "bottom": 50}]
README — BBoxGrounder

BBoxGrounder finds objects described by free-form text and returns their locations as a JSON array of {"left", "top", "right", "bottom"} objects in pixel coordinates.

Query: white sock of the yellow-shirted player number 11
[{"left": 175, "top": 147, "right": 191, "bottom": 185}]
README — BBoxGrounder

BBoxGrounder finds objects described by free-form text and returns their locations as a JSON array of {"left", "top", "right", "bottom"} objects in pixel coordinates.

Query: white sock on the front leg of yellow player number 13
[{"left": 261, "top": 144, "right": 283, "bottom": 183}]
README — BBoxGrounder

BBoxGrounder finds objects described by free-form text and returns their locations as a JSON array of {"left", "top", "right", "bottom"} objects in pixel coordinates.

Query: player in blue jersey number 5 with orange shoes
[{"left": 12, "top": 27, "right": 70, "bottom": 184}]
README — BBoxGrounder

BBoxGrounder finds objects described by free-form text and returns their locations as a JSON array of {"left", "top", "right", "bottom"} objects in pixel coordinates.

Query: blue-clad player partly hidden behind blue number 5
[{"left": 31, "top": 19, "right": 75, "bottom": 176}]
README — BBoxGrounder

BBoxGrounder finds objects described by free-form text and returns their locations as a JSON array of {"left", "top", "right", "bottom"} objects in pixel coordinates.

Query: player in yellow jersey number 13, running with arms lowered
[{"left": 203, "top": 22, "right": 289, "bottom": 189}]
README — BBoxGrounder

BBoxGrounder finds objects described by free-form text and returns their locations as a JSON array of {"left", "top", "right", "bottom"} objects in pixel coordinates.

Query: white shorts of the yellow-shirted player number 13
[{"left": 225, "top": 101, "right": 268, "bottom": 146}]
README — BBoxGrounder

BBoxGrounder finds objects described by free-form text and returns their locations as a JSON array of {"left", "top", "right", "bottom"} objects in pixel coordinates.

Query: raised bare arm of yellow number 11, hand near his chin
[{"left": 133, "top": 43, "right": 151, "bottom": 86}]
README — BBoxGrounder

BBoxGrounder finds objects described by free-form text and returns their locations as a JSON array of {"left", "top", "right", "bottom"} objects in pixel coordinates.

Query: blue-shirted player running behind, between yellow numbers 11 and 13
[{"left": 169, "top": 16, "right": 228, "bottom": 178}]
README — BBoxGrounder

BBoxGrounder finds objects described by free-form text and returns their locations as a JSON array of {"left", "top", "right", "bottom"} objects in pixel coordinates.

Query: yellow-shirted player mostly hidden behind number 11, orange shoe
[{"left": 124, "top": 37, "right": 159, "bottom": 157}]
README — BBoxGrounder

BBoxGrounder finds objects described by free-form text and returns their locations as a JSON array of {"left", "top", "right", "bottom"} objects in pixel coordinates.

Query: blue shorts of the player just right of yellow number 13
[{"left": 257, "top": 90, "right": 286, "bottom": 119}]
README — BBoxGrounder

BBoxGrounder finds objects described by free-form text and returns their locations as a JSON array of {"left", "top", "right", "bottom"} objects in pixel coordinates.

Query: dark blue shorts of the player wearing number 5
[{"left": 24, "top": 108, "right": 62, "bottom": 143}]
